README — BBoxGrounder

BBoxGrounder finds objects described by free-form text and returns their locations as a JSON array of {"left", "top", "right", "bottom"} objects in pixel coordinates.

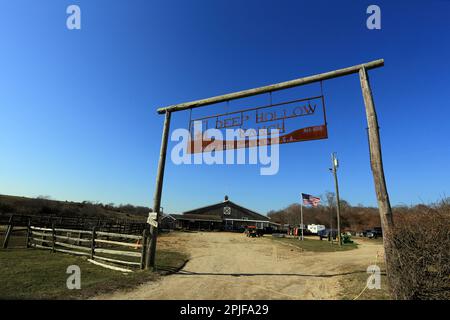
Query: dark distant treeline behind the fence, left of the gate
[{"left": 0, "top": 195, "right": 151, "bottom": 220}]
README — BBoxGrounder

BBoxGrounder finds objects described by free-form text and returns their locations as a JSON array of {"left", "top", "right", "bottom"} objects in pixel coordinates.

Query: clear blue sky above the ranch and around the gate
[{"left": 0, "top": 0, "right": 450, "bottom": 213}]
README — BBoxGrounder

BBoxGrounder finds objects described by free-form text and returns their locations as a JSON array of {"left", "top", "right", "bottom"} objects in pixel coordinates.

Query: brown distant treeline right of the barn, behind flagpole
[{"left": 267, "top": 192, "right": 450, "bottom": 232}]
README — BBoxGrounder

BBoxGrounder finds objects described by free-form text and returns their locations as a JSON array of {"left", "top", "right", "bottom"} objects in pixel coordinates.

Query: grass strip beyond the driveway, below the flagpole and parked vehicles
[{"left": 267, "top": 237, "right": 358, "bottom": 252}]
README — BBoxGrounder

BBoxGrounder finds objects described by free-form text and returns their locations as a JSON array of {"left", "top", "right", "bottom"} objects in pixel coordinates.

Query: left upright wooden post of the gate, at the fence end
[{"left": 146, "top": 111, "right": 171, "bottom": 269}]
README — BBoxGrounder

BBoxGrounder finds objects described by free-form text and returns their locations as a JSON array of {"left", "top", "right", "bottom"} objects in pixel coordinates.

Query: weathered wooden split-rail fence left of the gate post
[{"left": 0, "top": 215, "right": 148, "bottom": 272}]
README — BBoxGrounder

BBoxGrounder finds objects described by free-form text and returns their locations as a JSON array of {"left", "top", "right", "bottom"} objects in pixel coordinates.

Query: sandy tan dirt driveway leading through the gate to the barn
[{"left": 96, "top": 232, "right": 382, "bottom": 300}]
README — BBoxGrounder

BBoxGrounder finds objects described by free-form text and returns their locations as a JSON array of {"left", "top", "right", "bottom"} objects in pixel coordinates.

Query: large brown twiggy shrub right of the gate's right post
[{"left": 387, "top": 202, "right": 450, "bottom": 300}]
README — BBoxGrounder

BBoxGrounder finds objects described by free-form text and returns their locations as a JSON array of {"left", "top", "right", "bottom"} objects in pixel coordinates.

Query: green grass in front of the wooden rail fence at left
[{"left": 0, "top": 249, "right": 187, "bottom": 300}]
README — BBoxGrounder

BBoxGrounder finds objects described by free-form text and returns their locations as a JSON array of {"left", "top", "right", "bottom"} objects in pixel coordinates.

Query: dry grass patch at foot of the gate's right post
[{"left": 338, "top": 263, "right": 392, "bottom": 300}]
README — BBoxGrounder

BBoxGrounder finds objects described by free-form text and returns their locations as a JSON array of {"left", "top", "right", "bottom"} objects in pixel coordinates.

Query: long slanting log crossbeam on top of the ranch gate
[{"left": 157, "top": 59, "right": 384, "bottom": 114}]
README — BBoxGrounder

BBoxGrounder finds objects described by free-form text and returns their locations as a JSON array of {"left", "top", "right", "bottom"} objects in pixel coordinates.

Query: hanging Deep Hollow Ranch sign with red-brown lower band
[{"left": 188, "top": 96, "right": 328, "bottom": 153}]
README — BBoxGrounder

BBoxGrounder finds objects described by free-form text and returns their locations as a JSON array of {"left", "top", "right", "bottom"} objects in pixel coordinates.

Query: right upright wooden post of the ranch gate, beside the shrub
[{"left": 359, "top": 67, "right": 394, "bottom": 244}]
